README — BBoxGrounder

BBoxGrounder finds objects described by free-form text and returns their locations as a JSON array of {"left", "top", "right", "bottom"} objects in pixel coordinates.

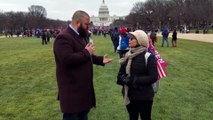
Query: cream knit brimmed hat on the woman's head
[{"left": 129, "top": 30, "right": 149, "bottom": 47}]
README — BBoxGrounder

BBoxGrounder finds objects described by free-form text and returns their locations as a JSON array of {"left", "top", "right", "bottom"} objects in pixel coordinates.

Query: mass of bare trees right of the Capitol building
[{"left": 126, "top": 0, "right": 213, "bottom": 29}]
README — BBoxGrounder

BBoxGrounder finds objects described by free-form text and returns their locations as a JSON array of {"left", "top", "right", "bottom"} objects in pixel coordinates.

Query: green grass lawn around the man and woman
[{"left": 0, "top": 36, "right": 213, "bottom": 120}]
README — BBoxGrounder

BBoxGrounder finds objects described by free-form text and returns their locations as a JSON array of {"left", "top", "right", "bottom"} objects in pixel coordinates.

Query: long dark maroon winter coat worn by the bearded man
[{"left": 54, "top": 27, "right": 104, "bottom": 113}]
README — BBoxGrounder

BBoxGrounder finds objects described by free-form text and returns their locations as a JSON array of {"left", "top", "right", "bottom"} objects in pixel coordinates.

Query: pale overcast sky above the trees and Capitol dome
[{"left": 0, "top": 0, "right": 145, "bottom": 20}]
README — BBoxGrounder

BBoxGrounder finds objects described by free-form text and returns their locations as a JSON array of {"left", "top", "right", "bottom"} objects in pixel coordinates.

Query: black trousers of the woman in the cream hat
[{"left": 127, "top": 100, "right": 153, "bottom": 120}]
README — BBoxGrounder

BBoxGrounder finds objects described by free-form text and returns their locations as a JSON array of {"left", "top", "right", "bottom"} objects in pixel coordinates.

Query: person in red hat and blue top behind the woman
[{"left": 117, "top": 28, "right": 130, "bottom": 58}]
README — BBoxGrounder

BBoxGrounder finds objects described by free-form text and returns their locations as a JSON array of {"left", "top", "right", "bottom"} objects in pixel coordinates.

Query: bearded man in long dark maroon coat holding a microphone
[{"left": 54, "top": 10, "right": 112, "bottom": 120}]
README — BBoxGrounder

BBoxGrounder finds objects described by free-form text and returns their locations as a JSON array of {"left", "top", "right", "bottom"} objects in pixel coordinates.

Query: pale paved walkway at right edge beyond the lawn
[{"left": 158, "top": 33, "right": 213, "bottom": 43}]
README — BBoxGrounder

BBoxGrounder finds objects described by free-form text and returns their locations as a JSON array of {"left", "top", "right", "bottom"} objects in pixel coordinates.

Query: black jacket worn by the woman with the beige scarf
[{"left": 117, "top": 52, "right": 158, "bottom": 100}]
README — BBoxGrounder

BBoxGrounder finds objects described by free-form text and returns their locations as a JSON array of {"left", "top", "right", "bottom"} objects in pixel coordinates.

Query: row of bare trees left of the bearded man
[{"left": 0, "top": 5, "right": 67, "bottom": 33}]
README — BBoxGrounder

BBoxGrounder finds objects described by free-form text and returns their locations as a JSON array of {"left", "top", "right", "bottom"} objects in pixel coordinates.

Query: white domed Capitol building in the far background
[{"left": 90, "top": 0, "right": 124, "bottom": 26}]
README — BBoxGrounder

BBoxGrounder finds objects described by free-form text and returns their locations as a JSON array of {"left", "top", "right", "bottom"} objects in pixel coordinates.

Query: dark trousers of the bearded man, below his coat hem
[{"left": 63, "top": 111, "right": 89, "bottom": 120}]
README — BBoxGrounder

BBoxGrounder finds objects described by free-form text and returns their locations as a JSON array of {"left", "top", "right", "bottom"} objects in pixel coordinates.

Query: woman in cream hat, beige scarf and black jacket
[{"left": 117, "top": 30, "right": 158, "bottom": 120}]
